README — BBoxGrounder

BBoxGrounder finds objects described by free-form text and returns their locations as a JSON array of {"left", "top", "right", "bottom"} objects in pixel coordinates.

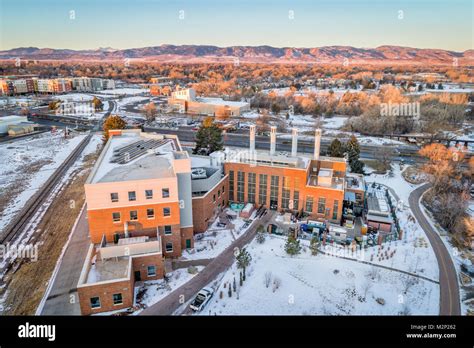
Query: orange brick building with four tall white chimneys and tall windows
[{"left": 224, "top": 126, "right": 347, "bottom": 223}]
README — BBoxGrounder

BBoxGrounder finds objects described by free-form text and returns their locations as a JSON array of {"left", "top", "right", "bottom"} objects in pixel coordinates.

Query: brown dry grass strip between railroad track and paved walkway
[{"left": 0, "top": 154, "right": 97, "bottom": 315}]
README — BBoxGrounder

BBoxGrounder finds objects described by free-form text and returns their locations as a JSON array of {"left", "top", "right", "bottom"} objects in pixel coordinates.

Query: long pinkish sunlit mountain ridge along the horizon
[{"left": 0, "top": 45, "right": 468, "bottom": 65}]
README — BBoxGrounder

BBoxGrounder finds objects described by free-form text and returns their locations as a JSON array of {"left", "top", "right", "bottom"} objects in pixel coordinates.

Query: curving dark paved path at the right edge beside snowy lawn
[{"left": 408, "top": 184, "right": 461, "bottom": 315}]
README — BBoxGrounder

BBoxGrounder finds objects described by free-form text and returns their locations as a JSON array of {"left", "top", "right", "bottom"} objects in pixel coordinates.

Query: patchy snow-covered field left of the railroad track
[{"left": 0, "top": 132, "right": 86, "bottom": 234}]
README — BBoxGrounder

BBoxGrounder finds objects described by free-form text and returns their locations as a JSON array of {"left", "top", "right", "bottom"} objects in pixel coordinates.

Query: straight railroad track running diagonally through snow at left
[{"left": 0, "top": 133, "right": 92, "bottom": 245}]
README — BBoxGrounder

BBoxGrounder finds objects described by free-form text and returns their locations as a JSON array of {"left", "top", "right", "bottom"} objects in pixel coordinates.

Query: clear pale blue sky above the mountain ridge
[{"left": 0, "top": 0, "right": 474, "bottom": 51}]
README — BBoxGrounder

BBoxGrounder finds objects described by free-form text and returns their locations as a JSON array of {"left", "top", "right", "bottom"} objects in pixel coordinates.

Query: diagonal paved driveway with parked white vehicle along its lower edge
[{"left": 140, "top": 211, "right": 272, "bottom": 315}]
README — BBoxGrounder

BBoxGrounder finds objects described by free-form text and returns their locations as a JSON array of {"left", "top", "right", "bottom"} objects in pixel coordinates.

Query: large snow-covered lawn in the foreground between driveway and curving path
[{"left": 200, "top": 236, "right": 439, "bottom": 315}]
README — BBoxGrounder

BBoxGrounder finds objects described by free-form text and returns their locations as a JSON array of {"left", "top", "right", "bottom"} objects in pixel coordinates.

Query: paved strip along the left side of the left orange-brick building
[{"left": 41, "top": 208, "right": 90, "bottom": 315}]
